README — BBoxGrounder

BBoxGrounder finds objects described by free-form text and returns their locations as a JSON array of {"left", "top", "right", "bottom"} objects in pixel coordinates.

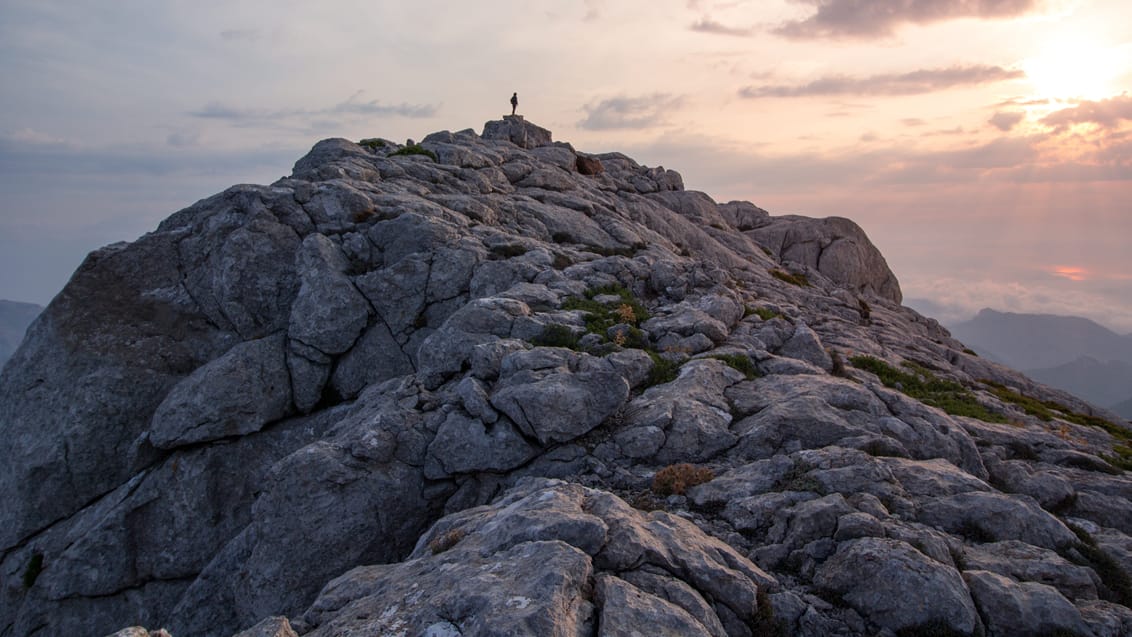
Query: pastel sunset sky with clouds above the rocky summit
[{"left": 0, "top": 0, "right": 1132, "bottom": 333}]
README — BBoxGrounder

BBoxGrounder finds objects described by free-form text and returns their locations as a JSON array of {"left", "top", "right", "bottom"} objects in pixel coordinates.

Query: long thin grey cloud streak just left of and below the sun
[{"left": 739, "top": 66, "right": 1024, "bottom": 100}]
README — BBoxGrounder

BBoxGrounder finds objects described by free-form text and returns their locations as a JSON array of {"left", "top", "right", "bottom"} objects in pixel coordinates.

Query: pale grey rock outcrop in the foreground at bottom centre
[{"left": 292, "top": 481, "right": 773, "bottom": 636}]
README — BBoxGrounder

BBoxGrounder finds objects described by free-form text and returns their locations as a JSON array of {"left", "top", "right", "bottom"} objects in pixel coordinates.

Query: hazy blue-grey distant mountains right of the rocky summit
[{"left": 947, "top": 309, "right": 1132, "bottom": 419}]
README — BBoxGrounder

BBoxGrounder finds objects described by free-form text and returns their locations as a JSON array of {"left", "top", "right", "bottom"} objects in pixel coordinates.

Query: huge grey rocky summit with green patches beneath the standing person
[{"left": 0, "top": 118, "right": 1132, "bottom": 637}]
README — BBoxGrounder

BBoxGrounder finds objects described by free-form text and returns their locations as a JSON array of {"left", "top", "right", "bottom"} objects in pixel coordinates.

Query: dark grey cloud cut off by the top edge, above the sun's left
[{"left": 774, "top": 0, "right": 1038, "bottom": 40}]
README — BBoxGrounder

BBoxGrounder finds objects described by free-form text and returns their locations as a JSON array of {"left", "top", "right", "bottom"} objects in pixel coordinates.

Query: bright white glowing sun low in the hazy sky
[{"left": 1021, "top": 38, "right": 1125, "bottom": 101}]
